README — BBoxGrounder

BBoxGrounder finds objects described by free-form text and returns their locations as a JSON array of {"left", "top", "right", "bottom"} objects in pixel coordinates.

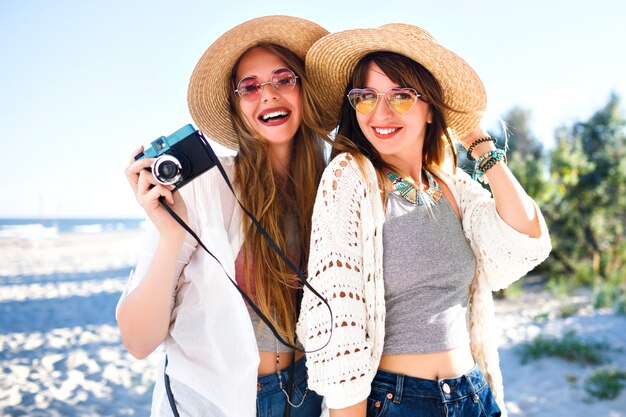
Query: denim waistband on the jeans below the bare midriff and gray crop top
[{"left": 372, "top": 365, "right": 487, "bottom": 403}]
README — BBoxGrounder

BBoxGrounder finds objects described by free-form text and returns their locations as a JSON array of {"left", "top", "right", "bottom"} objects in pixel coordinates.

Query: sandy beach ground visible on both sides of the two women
[{"left": 0, "top": 231, "right": 626, "bottom": 417}]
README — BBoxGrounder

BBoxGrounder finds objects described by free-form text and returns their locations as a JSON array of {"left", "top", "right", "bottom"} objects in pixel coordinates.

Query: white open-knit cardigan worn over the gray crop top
[{"left": 297, "top": 153, "right": 551, "bottom": 416}]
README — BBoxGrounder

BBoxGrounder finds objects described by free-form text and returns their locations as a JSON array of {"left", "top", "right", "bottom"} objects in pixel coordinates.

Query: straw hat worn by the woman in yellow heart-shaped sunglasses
[{"left": 306, "top": 23, "right": 487, "bottom": 138}]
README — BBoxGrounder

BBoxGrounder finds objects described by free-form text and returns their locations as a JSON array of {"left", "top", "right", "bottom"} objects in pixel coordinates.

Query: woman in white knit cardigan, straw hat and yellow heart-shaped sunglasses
[{"left": 298, "top": 24, "right": 550, "bottom": 417}]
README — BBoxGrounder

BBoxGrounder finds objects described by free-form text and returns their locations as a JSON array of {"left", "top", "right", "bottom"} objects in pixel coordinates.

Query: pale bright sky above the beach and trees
[{"left": 0, "top": 0, "right": 626, "bottom": 218}]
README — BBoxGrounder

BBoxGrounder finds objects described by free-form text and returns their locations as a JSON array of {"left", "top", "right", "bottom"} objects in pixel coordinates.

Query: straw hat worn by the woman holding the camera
[{"left": 187, "top": 16, "right": 328, "bottom": 150}]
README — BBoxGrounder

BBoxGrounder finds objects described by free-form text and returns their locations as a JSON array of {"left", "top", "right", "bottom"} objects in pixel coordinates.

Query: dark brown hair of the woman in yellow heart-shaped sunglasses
[{"left": 331, "top": 51, "right": 457, "bottom": 180}]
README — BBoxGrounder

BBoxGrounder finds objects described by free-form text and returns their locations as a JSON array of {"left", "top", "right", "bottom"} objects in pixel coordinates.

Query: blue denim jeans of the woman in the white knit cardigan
[{"left": 367, "top": 365, "right": 500, "bottom": 417}]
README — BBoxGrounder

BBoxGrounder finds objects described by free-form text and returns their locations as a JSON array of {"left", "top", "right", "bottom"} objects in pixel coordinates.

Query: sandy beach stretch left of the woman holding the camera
[{"left": 0, "top": 231, "right": 161, "bottom": 417}]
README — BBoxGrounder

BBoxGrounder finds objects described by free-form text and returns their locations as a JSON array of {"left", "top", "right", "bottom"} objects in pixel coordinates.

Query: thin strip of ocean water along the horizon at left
[{"left": 0, "top": 219, "right": 145, "bottom": 239}]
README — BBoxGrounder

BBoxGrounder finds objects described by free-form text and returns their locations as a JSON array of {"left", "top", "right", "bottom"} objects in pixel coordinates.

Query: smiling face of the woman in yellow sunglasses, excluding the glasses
[{"left": 356, "top": 62, "right": 432, "bottom": 170}]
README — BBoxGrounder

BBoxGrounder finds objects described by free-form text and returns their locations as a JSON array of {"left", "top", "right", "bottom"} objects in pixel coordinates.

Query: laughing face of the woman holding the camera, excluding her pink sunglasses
[{"left": 236, "top": 48, "right": 302, "bottom": 147}]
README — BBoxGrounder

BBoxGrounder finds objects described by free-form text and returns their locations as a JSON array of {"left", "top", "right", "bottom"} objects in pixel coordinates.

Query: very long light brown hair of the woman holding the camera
[{"left": 229, "top": 44, "right": 326, "bottom": 344}]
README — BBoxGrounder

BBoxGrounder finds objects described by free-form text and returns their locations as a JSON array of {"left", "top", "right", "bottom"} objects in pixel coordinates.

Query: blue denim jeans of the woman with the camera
[{"left": 256, "top": 357, "right": 322, "bottom": 417}]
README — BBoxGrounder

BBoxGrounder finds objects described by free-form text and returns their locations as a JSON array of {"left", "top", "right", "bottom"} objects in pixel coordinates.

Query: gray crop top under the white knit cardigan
[{"left": 383, "top": 193, "right": 476, "bottom": 355}]
